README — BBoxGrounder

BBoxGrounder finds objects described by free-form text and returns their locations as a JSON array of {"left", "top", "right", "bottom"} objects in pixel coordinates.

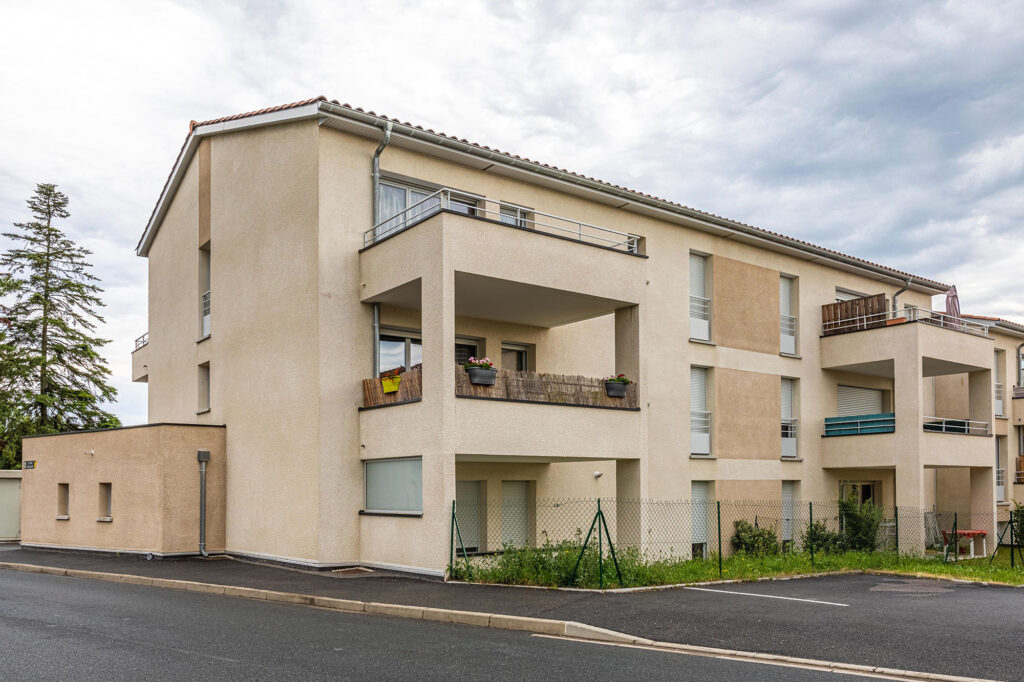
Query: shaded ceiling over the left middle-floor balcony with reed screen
[{"left": 364, "top": 272, "right": 631, "bottom": 328}]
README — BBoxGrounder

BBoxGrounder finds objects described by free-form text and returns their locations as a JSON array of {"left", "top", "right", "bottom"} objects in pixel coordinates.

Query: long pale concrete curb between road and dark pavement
[{"left": 0, "top": 561, "right": 984, "bottom": 682}]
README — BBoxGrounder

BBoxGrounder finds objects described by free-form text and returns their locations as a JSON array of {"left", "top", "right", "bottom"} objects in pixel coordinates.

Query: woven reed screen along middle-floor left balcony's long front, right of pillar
[{"left": 455, "top": 365, "right": 638, "bottom": 410}]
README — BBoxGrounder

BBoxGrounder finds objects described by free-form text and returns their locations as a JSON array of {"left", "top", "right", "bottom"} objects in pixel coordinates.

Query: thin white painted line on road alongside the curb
[{"left": 531, "top": 633, "right": 993, "bottom": 682}]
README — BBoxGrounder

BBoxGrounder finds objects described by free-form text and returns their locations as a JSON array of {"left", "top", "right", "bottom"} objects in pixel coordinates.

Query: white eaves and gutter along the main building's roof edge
[{"left": 136, "top": 97, "right": 949, "bottom": 295}]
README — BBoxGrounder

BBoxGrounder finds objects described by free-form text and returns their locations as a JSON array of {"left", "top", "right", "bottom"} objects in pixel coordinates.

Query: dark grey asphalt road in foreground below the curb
[{"left": 0, "top": 571, "right": 880, "bottom": 681}]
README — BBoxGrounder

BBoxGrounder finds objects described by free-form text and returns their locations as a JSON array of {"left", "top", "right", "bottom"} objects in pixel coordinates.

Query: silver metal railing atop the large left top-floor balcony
[{"left": 362, "top": 187, "right": 640, "bottom": 254}]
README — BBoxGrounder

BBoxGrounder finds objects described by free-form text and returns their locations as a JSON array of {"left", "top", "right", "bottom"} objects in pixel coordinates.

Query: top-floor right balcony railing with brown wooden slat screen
[{"left": 821, "top": 294, "right": 988, "bottom": 338}]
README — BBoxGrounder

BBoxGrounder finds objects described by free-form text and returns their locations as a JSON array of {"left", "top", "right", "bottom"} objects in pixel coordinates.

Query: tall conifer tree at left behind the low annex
[{"left": 0, "top": 183, "right": 120, "bottom": 433}]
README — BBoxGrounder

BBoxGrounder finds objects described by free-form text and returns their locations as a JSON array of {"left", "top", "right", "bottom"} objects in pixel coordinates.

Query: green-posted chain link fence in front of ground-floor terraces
[{"left": 451, "top": 499, "right": 1001, "bottom": 562}]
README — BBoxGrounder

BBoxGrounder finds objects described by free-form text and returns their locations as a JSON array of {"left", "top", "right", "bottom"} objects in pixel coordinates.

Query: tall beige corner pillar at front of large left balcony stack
[{"left": 421, "top": 249, "right": 456, "bottom": 569}]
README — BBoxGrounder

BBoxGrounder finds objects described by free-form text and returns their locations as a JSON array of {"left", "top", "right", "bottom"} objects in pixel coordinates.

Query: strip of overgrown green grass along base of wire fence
[{"left": 452, "top": 542, "right": 1024, "bottom": 588}]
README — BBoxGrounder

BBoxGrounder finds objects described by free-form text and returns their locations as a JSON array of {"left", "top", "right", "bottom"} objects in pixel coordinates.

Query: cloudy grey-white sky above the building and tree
[{"left": 0, "top": 0, "right": 1024, "bottom": 424}]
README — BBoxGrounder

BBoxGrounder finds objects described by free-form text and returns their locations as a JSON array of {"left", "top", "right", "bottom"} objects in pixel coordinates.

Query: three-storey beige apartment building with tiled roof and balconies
[{"left": 18, "top": 98, "right": 1024, "bottom": 573}]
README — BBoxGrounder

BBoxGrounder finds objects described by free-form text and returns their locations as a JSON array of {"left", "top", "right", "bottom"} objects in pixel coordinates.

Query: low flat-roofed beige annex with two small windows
[{"left": 22, "top": 424, "right": 227, "bottom": 556}]
